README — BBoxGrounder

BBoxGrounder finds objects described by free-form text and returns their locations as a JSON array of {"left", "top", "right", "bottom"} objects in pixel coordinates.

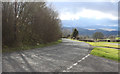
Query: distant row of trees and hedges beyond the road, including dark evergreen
[{"left": 62, "top": 28, "right": 116, "bottom": 40}]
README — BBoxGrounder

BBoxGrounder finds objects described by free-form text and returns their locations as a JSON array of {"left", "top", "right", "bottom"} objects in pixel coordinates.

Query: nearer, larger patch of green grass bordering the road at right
[{"left": 90, "top": 47, "right": 120, "bottom": 62}]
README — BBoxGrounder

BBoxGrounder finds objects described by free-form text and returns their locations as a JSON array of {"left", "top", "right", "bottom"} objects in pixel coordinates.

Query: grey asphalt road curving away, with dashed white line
[{"left": 2, "top": 39, "right": 118, "bottom": 72}]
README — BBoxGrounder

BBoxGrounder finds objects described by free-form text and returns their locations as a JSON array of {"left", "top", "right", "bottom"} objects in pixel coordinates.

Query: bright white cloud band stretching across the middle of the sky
[{"left": 60, "top": 8, "right": 118, "bottom": 20}]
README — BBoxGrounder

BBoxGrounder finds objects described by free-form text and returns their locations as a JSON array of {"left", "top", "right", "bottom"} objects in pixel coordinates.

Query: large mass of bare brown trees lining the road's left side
[{"left": 2, "top": 2, "right": 61, "bottom": 46}]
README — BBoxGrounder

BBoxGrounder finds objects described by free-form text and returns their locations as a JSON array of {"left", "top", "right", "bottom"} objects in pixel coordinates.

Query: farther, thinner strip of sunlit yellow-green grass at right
[{"left": 87, "top": 42, "right": 120, "bottom": 48}]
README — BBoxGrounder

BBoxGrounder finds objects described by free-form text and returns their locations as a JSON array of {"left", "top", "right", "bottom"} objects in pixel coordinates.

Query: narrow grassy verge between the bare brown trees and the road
[{"left": 2, "top": 39, "right": 62, "bottom": 53}]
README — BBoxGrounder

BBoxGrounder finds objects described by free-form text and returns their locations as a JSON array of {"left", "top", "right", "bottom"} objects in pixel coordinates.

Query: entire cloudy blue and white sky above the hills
[{"left": 47, "top": 0, "right": 118, "bottom": 31}]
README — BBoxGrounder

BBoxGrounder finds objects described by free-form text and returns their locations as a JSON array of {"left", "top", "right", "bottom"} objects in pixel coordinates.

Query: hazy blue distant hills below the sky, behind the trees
[{"left": 62, "top": 27, "right": 118, "bottom": 36}]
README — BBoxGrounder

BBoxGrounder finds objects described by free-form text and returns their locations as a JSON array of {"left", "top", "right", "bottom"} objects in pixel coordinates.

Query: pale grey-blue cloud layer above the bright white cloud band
[{"left": 53, "top": 2, "right": 118, "bottom": 16}]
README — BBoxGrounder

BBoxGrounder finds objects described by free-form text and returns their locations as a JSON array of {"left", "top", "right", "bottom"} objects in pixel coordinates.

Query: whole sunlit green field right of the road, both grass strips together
[{"left": 87, "top": 42, "right": 120, "bottom": 61}]
